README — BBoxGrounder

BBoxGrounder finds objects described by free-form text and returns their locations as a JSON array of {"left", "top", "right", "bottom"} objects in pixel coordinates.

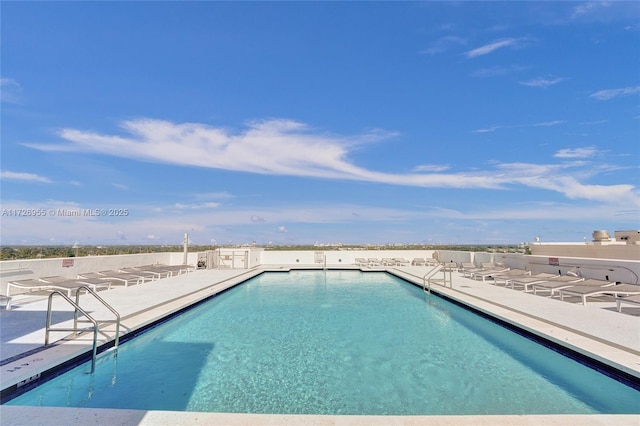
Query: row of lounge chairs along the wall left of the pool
[{"left": 6, "top": 264, "right": 194, "bottom": 310}]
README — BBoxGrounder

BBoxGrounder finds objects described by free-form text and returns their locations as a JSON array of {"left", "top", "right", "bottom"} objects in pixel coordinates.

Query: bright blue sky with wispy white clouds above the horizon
[{"left": 0, "top": 2, "right": 640, "bottom": 245}]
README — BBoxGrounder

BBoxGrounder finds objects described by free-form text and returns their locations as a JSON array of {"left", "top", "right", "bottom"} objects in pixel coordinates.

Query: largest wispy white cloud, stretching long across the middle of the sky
[{"left": 22, "top": 115, "right": 634, "bottom": 204}]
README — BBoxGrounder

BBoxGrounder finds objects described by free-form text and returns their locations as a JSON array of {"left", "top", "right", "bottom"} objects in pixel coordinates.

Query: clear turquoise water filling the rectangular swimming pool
[{"left": 9, "top": 271, "right": 640, "bottom": 415}]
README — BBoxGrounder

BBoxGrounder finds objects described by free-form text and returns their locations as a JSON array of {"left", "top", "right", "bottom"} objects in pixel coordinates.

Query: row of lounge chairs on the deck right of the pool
[{"left": 461, "top": 263, "right": 640, "bottom": 312}]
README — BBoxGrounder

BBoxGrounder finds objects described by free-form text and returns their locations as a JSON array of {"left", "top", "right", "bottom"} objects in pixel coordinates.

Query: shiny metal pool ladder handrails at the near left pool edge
[{"left": 44, "top": 286, "right": 120, "bottom": 373}]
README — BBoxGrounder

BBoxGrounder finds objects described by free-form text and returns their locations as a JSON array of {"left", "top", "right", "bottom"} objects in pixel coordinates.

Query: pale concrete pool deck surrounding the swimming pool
[{"left": 0, "top": 265, "right": 640, "bottom": 426}]
